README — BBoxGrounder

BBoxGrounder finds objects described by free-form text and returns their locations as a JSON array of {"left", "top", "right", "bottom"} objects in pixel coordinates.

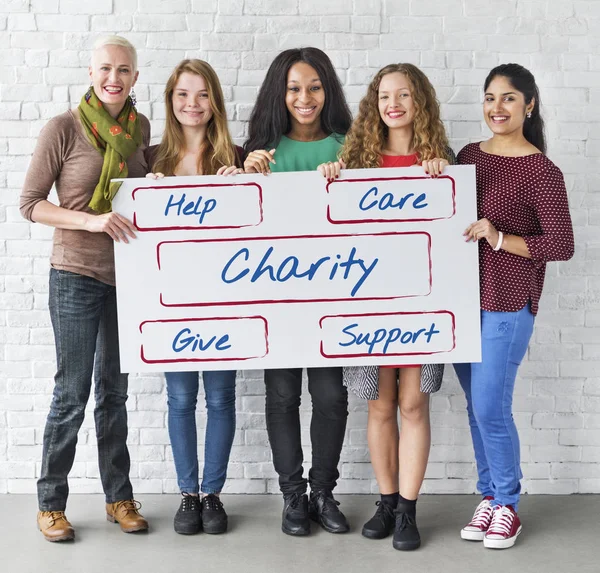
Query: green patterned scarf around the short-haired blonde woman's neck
[{"left": 79, "top": 88, "right": 142, "bottom": 213}]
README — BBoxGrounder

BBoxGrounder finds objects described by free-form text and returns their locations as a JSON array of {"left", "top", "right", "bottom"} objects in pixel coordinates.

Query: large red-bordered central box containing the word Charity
[{"left": 158, "top": 232, "right": 431, "bottom": 306}]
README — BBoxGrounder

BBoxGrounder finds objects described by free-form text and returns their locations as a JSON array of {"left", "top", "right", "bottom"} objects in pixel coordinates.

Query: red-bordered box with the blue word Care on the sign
[{"left": 327, "top": 176, "right": 455, "bottom": 223}]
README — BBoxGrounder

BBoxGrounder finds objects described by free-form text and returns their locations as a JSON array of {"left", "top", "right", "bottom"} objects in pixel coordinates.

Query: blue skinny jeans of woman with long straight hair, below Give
[{"left": 165, "top": 370, "right": 236, "bottom": 494}]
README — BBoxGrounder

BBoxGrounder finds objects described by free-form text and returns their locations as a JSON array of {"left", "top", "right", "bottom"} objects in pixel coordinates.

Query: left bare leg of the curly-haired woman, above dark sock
[{"left": 367, "top": 368, "right": 398, "bottom": 495}]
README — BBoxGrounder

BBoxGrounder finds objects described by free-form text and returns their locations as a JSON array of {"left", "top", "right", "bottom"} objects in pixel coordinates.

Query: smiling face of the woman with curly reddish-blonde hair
[{"left": 378, "top": 72, "right": 417, "bottom": 129}]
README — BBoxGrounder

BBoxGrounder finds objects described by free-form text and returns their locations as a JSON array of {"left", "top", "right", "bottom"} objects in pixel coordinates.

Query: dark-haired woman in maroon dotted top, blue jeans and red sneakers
[{"left": 455, "top": 64, "right": 574, "bottom": 549}]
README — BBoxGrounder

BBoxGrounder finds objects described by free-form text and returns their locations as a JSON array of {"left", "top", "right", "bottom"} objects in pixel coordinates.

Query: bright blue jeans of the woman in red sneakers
[{"left": 454, "top": 304, "right": 535, "bottom": 511}]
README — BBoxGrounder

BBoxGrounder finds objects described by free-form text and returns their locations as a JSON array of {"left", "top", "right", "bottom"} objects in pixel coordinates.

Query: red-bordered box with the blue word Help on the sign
[{"left": 132, "top": 178, "right": 262, "bottom": 231}]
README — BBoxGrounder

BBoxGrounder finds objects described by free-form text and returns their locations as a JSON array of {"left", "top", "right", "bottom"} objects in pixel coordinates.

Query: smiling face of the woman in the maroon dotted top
[{"left": 483, "top": 76, "right": 535, "bottom": 135}]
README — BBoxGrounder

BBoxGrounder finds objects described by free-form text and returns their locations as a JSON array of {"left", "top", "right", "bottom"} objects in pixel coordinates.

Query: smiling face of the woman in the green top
[{"left": 285, "top": 62, "right": 325, "bottom": 130}]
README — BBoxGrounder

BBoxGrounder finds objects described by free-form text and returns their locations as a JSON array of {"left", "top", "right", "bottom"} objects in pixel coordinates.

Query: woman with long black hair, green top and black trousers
[{"left": 244, "top": 48, "right": 352, "bottom": 535}]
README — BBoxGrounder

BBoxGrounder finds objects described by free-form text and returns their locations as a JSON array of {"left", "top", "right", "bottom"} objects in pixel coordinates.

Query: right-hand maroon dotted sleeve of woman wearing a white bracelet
[{"left": 523, "top": 165, "right": 575, "bottom": 262}]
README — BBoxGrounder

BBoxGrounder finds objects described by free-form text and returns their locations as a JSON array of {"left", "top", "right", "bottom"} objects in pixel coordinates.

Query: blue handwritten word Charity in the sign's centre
[{"left": 221, "top": 246, "right": 379, "bottom": 296}]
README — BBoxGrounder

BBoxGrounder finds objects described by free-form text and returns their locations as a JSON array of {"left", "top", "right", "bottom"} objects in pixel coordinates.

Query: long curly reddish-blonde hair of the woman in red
[{"left": 340, "top": 64, "right": 450, "bottom": 169}]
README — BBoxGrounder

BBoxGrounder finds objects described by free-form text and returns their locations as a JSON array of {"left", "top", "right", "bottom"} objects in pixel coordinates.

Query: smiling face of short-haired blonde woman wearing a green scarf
[{"left": 88, "top": 44, "right": 138, "bottom": 117}]
